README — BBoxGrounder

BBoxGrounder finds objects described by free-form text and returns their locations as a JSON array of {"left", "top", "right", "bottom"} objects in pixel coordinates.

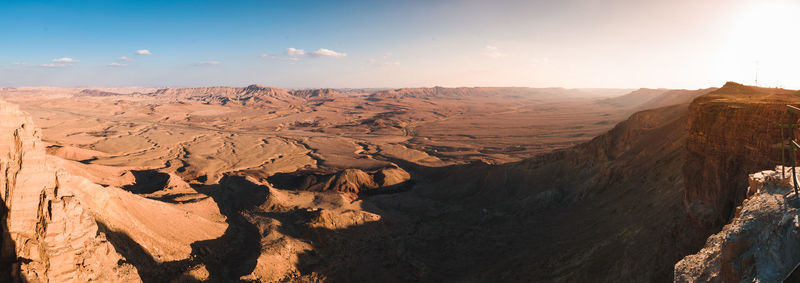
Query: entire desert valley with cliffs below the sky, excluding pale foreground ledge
[{"left": 0, "top": 83, "right": 800, "bottom": 282}]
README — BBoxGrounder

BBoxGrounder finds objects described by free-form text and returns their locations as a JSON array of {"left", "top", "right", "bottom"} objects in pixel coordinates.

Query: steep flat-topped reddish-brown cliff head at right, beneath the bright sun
[{"left": 683, "top": 83, "right": 800, "bottom": 233}]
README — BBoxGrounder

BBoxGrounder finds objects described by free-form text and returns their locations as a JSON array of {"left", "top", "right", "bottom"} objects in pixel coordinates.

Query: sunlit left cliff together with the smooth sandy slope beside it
[{"left": 0, "top": 101, "right": 227, "bottom": 282}]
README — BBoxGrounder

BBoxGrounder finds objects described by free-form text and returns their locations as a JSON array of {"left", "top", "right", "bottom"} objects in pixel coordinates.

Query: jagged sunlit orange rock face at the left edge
[{"left": 0, "top": 101, "right": 141, "bottom": 282}]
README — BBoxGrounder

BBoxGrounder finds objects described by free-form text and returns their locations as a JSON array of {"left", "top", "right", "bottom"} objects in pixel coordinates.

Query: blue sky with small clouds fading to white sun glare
[{"left": 0, "top": 0, "right": 800, "bottom": 89}]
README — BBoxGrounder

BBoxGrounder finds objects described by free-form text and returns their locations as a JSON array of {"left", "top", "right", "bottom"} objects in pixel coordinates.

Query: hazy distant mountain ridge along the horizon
[{"left": 76, "top": 84, "right": 692, "bottom": 110}]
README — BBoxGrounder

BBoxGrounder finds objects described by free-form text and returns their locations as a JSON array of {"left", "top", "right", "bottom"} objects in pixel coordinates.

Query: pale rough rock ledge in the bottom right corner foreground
[{"left": 674, "top": 166, "right": 800, "bottom": 282}]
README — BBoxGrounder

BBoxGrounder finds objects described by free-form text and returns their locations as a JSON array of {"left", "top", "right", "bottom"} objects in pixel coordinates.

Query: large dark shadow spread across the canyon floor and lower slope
[{"left": 103, "top": 144, "right": 704, "bottom": 282}]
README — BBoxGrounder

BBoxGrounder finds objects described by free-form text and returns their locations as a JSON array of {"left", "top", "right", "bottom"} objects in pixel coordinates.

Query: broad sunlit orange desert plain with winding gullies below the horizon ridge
[{"left": 2, "top": 86, "right": 636, "bottom": 171}]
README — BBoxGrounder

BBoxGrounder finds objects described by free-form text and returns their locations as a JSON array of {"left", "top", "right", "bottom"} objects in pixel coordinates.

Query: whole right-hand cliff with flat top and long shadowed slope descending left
[{"left": 382, "top": 83, "right": 800, "bottom": 281}]
